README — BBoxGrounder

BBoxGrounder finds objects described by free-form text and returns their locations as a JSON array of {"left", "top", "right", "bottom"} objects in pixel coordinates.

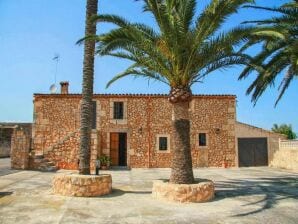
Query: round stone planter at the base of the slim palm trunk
[{"left": 53, "top": 174, "right": 112, "bottom": 197}]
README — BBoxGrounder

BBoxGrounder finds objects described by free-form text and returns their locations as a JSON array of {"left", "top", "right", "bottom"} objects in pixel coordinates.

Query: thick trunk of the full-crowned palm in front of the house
[{"left": 170, "top": 87, "right": 194, "bottom": 184}]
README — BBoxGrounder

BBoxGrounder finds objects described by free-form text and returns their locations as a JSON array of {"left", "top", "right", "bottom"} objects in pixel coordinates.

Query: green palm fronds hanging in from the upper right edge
[{"left": 239, "top": 0, "right": 298, "bottom": 106}]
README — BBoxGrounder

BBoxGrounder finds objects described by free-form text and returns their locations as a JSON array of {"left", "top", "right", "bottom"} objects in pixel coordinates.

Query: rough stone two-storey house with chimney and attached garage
[{"left": 11, "top": 82, "right": 285, "bottom": 171}]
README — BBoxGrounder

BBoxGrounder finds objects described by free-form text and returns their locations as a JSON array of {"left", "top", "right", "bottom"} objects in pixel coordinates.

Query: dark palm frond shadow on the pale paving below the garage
[{"left": 214, "top": 175, "right": 298, "bottom": 217}]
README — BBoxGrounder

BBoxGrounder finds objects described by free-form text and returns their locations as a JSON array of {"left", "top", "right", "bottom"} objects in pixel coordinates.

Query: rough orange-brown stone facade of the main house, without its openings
[{"left": 33, "top": 94, "right": 236, "bottom": 170}]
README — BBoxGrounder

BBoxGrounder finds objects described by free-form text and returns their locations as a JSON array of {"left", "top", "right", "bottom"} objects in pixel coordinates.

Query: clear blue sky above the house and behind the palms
[{"left": 0, "top": 0, "right": 298, "bottom": 132}]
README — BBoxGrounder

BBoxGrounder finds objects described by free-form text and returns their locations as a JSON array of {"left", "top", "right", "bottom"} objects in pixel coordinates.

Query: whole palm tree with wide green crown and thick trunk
[{"left": 92, "top": 0, "right": 252, "bottom": 184}]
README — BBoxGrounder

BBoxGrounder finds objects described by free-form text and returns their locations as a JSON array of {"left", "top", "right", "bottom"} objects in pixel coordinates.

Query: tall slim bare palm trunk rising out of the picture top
[{"left": 79, "top": 0, "right": 98, "bottom": 175}]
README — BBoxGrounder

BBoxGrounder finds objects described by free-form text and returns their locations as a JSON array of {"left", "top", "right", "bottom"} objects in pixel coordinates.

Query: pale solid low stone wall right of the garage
[{"left": 270, "top": 149, "right": 298, "bottom": 171}]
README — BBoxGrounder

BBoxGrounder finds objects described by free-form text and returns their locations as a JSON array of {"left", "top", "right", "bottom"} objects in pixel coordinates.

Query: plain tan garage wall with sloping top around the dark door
[{"left": 235, "top": 122, "right": 286, "bottom": 165}]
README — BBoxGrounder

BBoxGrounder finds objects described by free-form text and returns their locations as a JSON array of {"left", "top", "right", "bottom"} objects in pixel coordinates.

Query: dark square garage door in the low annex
[{"left": 238, "top": 138, "right": 268, "bottom": 167}]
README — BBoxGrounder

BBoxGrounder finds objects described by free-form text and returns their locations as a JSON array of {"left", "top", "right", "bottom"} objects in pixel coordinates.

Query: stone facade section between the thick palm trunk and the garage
[{"left": 191, "top": 97, "right": 236, "bottom": 167}]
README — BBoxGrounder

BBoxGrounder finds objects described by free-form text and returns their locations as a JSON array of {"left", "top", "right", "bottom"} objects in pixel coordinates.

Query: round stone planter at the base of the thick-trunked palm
[{"left": 152, "top": 180, "right": 214, "bottom": 203}]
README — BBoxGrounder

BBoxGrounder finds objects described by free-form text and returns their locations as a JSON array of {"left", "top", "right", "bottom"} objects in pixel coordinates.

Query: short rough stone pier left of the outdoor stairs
[{"left": 11, "top": 126, "right": 32, "bottom": 169}]
